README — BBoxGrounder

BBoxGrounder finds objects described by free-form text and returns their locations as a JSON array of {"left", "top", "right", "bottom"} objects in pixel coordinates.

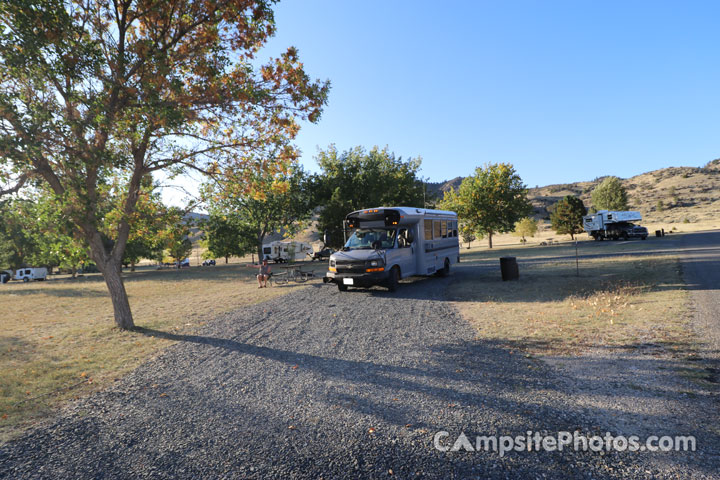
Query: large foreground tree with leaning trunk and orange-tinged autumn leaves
[{"left": 0, "top": 0, "right": 329, "bottom": 328}]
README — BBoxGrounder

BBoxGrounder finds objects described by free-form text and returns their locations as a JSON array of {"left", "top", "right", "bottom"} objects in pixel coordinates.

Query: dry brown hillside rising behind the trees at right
[{"left": 428, "top": 159, "right": 720, "bottom": 223}]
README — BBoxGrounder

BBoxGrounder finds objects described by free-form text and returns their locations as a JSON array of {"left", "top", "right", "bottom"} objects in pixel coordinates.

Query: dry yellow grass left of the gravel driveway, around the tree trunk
[{"left": 0, "top": 263, "right": 322, "bottom": 441}]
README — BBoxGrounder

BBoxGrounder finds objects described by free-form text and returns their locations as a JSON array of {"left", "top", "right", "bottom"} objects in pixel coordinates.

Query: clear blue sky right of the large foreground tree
[{"left": 261, "top": 0, "right": 720, "bottom": 186}]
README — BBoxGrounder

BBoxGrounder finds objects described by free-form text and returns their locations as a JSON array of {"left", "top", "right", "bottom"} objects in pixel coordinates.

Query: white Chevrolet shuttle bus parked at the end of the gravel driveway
[{"left": 325, "top": 207, "right": 460, "bottom": 291}]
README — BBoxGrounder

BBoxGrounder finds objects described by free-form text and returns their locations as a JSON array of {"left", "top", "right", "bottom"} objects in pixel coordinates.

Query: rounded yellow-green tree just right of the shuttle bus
[{"left": 440, "top": 163, "right": 532, "bottom": 248}]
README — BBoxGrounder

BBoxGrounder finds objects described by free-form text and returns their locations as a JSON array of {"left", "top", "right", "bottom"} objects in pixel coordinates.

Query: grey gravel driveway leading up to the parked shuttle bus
[{"left": 0, "top": 270, "right": 715, "bottom": 479}]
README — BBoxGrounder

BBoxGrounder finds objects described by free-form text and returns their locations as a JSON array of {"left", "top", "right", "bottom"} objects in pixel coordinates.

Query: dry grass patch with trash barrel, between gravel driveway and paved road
[{"left": 452, "top": 237, "right": 692, "bottom": 355}]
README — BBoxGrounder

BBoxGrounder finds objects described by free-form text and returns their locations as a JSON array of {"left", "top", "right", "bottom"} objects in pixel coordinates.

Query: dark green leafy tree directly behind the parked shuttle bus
[{"left": 317, "top": 145, "right": 424, "bottom": 247}]
